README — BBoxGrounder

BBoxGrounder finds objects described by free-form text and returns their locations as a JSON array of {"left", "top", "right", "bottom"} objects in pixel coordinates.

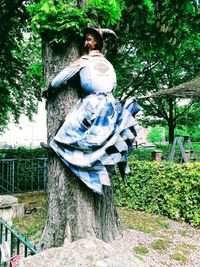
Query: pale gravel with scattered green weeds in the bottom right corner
[{"left": 112, "top": 220, "right": 200, "bottom": 267}]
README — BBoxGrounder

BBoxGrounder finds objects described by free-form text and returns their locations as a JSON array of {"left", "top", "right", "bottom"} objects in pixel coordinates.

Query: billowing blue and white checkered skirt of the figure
[{"left": 50, "top": 94, "right": 139, "bottom": 195}]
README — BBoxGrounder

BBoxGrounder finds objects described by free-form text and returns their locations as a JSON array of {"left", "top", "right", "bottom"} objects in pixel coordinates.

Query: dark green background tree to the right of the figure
[{"left": 112, "top": 0, "right": 200, "bottom": 142}]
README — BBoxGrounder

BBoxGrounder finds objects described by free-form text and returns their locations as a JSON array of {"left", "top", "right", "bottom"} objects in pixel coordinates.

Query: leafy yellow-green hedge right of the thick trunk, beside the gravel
[{"left": 114, "top": 161, "right": 200, "bottom": 226}]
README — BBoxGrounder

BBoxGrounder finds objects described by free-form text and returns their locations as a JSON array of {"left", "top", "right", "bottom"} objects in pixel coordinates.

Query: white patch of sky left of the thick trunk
[{"left": 0, "top": 101, "right": 47, "bottom": 147}]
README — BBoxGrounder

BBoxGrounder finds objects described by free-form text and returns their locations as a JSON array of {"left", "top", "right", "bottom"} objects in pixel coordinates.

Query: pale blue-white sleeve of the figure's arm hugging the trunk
[{"left": 51, "top": 58, "right": 82, "bottom": 88}]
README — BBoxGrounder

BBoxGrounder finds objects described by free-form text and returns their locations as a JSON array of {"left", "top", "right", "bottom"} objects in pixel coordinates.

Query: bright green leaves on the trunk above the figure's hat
[{"left": 28, "top": 0, "right": 121, "bottom": 42}]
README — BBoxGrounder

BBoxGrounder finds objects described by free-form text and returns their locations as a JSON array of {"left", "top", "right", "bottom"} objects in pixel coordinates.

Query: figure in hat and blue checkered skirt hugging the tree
[{"left": 42, "top": 25, "right": 139, "bottom": 195}]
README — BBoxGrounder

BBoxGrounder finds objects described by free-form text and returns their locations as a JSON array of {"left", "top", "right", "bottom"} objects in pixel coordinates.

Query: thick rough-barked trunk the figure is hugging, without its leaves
[{"left": 40, "top": 42, "right": 118, "bottom": 249}]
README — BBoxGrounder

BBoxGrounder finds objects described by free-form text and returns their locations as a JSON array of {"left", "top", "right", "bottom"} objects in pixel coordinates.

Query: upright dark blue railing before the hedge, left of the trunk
[{"left": 0, "top": 158, "right": 47, "bottom": 194}]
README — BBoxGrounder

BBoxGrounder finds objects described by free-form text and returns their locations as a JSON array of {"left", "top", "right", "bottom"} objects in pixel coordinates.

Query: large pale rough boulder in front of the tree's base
[{"left": 17, "top": 238, "right": 149, "bottom": 267}]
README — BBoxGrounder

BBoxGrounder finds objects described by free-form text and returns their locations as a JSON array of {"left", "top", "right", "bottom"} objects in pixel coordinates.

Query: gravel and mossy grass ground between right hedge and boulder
[{"left": 113, "top": 209, "right": 200, "bottom": 267}]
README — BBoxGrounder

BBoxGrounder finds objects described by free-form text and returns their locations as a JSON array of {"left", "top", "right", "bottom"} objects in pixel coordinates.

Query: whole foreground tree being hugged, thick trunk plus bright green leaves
[{"left": 29, "top": 0, "right": 121, "bottom": 248}]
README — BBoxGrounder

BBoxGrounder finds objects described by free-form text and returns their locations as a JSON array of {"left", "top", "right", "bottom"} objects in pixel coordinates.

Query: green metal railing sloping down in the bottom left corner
[{"left": 0, "top": 218, "right": 39, "bottom": 266}]
